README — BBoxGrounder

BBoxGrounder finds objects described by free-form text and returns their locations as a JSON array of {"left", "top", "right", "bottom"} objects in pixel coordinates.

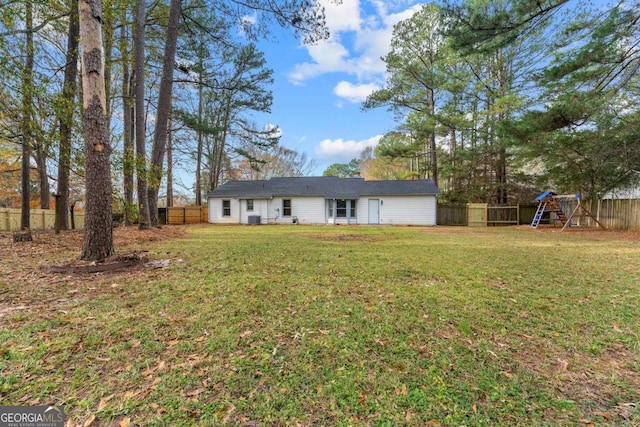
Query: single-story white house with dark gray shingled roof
[{"left": 207, "top": 176, "right": 440, "bottom": 225}]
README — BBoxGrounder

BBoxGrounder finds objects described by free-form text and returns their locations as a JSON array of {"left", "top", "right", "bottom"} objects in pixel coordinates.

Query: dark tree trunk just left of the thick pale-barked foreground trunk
[{"left": 56, "top": 0, "right": 80, "bottom": 230}]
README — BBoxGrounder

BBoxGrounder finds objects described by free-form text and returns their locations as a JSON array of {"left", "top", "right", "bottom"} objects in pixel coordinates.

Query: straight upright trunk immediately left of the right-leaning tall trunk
[{"left": 133, "top": 0, "right": 151, "bottom": 230}]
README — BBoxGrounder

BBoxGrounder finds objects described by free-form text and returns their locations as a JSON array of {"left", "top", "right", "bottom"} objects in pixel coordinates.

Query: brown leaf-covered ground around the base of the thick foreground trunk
[{"left": 0, "top": 226, "right": 186, "bottom": 317}]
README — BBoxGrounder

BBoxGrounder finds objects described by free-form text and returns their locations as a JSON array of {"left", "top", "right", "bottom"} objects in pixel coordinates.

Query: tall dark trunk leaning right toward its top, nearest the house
[{"left": 149, "top": 0, "right": 182, "bottom": 226}]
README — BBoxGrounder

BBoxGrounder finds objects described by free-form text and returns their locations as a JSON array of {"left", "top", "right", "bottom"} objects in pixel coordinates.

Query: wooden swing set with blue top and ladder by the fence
[{"left": 531, "top": 191, "right": 605, "bottom": 231}]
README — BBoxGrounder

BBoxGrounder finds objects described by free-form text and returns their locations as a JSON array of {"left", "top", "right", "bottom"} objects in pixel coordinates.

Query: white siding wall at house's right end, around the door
[{"left": 356, "top": 196, "right": 436, "bottom": 225}]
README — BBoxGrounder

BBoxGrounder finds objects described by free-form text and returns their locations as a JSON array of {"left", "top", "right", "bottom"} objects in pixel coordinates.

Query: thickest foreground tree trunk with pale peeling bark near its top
[{"left": 78, "top": 0, "right": 114, "bottom": 261}]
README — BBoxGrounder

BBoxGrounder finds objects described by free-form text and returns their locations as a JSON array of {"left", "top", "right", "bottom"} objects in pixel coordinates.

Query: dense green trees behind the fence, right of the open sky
[{"left": 325, "top": 0, "right": 640, "bottom": 204}]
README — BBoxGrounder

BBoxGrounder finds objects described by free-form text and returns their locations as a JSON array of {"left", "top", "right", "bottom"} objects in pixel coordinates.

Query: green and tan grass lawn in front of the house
[{"left": 0, "top": 226, "right": 640, "bottom": 426}]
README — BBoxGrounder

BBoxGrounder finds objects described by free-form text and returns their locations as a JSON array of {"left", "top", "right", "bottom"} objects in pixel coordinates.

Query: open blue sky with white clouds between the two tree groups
[{"left": 250, "top": 0, "right": 421, "bottom": 175}]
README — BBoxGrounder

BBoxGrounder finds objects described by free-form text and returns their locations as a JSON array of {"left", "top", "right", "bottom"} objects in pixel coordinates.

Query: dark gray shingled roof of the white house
[{"left": 208, "top": 176, "right": 440, "bottom": 199}]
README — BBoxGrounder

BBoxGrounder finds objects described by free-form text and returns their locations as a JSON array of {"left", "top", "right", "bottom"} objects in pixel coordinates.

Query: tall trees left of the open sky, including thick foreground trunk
[{"left": 0, "top": 0, "right": 328, "bottom": 260}]
